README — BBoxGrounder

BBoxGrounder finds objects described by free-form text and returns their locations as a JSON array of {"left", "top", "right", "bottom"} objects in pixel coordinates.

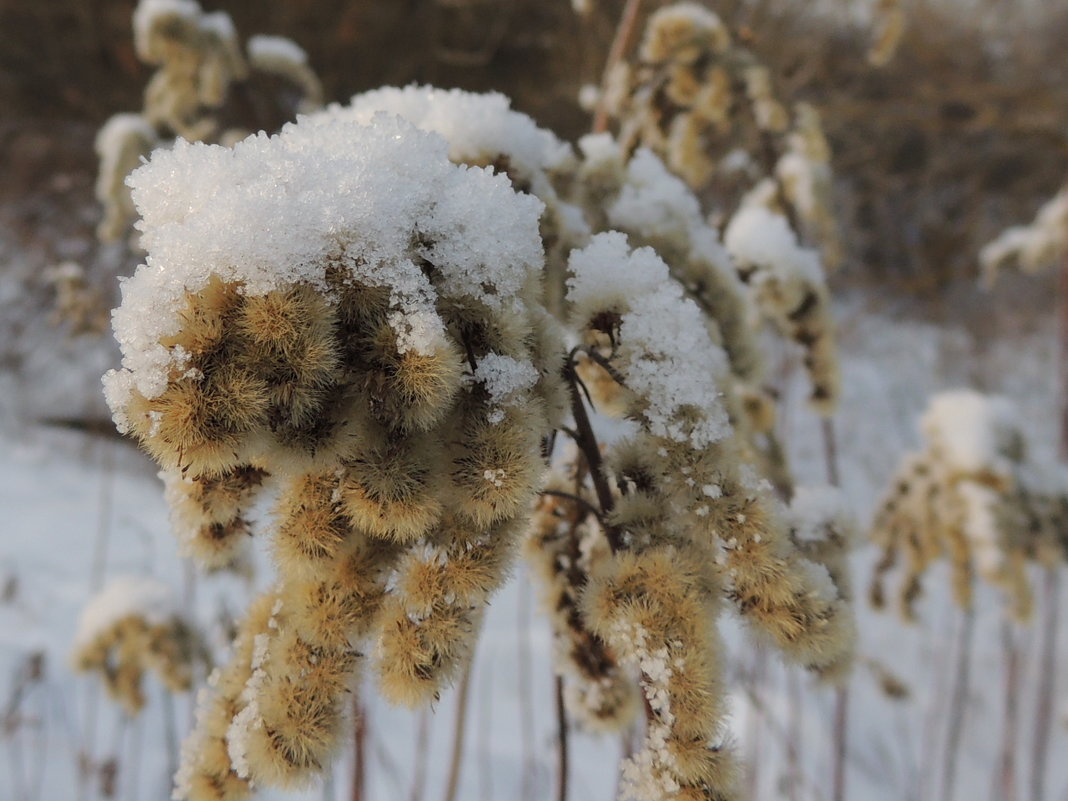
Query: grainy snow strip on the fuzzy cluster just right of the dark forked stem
[{"left": 567, "top": 232, "right": 731, "bottom": 449}]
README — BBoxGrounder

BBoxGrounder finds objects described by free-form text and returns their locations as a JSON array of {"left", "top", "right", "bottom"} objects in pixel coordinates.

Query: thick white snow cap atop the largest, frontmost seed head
[{"left": 105, "top": 114, "right": 543, "bottom": 426}]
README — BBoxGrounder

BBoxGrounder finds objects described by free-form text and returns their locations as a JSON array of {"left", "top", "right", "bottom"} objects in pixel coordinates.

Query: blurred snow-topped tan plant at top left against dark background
[{"left": 96, "top": 0, "right": 323, "bottom": 241}]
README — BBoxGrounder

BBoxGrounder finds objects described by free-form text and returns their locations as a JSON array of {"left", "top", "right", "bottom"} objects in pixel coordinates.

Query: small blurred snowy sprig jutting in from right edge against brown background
[{"left": 979, "top": 186, "right": 1068, "bottom": 286}]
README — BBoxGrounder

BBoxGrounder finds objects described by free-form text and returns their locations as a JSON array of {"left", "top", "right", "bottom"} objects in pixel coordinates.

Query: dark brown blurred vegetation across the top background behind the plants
[{"left": 0, "top": 0, "right": 1068, "bottom": 292}]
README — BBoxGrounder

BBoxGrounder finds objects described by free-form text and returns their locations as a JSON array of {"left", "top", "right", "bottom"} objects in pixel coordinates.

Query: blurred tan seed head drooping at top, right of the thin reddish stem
[{"left": 598, "top": 2, "right": 842, "bottom": 414}]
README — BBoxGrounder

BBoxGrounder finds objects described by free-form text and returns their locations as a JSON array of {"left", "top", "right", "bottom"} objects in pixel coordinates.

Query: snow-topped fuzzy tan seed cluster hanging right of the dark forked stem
[{"left": 568, "top": 233, "right": 853, "bottom": 799}]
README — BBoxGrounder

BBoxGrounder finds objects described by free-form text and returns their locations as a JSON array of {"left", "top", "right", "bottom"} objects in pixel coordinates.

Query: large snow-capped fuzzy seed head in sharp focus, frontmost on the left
[{"left": 106, "top": 110, "right": 560, "bottom": 801}]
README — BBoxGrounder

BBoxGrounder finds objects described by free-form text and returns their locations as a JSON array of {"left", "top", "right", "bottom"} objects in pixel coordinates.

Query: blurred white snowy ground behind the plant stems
[{"left": 0, "top": 241, "right": 1068, "bottom": 801}]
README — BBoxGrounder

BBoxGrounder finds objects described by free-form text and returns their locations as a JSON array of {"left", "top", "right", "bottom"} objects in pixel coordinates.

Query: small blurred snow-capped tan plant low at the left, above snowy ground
[{"left": 72, "top": 577, "right": 201, "bottom": 716}]
